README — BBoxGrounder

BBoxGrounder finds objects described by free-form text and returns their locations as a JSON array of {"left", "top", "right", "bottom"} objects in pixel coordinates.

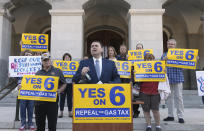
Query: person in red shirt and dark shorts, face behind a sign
[{"left": 140, "top": 53, "right": 161, "bottom": 131}]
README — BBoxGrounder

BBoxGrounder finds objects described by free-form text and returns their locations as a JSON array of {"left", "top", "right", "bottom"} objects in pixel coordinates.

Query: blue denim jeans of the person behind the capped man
[{"left": 20, "top": 100, "right": 34, "bottom": 126}]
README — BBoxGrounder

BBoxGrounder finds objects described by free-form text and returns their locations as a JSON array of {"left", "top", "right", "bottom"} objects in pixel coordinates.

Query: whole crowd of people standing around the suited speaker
[{"left": 15, "top": 39, "right": 185, "bottom": 131}]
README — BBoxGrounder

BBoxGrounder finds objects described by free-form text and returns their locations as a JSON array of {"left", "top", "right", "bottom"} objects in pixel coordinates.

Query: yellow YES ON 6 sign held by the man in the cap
[{"left": 18, "top": 75, "right": 59, "bottom": 102}]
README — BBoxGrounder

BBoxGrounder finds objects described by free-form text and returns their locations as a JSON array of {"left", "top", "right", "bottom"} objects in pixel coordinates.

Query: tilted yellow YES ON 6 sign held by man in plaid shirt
[{"left": 166, "top": 49, "right": 198, "bottom": 69}]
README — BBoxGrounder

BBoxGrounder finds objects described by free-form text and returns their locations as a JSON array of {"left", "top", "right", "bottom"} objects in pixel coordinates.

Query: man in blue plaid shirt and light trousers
[{"left": 162, "top": 39, "right": 184, "bottom": 123}]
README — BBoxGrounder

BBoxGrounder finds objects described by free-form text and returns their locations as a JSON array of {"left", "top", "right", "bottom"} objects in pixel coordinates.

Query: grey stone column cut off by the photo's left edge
[{"left": 0, "top": 10, "right": 11, "bottom": 88}]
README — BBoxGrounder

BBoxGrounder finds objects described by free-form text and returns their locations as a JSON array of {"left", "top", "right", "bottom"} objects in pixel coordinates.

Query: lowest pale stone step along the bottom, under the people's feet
[{"left": 0, "top": 106, "right": 204, "bottom": 131}]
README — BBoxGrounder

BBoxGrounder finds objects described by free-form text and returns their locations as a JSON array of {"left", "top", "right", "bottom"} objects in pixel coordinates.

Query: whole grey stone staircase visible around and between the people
[{"left": 0, "top": 90, "right": 204, "bottom": 131}]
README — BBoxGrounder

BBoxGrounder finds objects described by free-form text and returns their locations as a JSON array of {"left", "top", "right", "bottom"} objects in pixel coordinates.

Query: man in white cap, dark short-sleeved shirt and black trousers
[{"left": 35, "top": 53, "right": 66, "bottom": 131}]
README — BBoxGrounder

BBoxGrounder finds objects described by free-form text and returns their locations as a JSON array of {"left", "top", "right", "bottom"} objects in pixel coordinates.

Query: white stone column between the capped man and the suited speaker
[{"left": 50, "top": 10, "right": 84, "bottom": 60}]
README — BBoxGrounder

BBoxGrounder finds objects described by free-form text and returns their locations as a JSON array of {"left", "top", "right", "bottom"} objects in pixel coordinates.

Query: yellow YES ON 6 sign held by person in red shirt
[{"left": 134, "top": 61, "right": 166, "bottom": 81}]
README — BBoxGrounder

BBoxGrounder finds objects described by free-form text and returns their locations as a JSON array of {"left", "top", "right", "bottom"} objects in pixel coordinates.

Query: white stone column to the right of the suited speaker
[{"left": 129, "top": 9, "right": 165, "bottom": 59}]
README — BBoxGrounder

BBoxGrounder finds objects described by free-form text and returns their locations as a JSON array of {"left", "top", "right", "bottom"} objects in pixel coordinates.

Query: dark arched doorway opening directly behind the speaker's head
[{"left": 85, "top": 30, "right": 123, "bottom": 57}]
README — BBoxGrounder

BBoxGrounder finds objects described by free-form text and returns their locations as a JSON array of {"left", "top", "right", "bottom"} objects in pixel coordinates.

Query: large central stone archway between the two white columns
[{"left": 83, "top": 0, "right": 130, "bottom": 57}]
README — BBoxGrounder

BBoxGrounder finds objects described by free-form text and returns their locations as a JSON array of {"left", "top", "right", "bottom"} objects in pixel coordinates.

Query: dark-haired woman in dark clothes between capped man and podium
[{"left": 59, "top": 53, "right": 72, "bottom": 118}]
